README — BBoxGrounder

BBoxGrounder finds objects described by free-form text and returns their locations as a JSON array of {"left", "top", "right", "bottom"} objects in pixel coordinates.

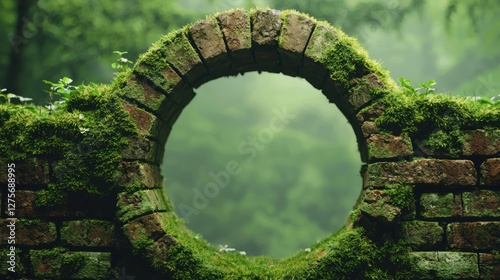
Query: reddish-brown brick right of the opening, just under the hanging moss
[{"left": 366, "top": 134, "right": 413, "bottom": 160}]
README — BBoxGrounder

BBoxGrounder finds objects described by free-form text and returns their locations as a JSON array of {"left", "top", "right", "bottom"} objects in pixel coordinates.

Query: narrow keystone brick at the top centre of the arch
[{"left": 250, "top": 9, "right": 283, "bottom": 73}]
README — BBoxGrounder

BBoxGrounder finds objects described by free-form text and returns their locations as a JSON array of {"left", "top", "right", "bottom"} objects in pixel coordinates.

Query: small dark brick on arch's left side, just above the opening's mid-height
[{"left": 121, "top": 138, "right": 161, "bottom": 165}]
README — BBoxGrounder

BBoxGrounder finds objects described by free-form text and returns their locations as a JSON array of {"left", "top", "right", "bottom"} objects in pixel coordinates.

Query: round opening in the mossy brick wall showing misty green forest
[{"left": 162, "top": 72, "right": 362, "bottom": 257}]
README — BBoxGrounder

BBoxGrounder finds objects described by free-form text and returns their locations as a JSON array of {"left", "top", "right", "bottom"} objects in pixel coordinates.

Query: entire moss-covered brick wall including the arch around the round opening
[{"left": 0, "top": 9, "right": 500, "bottom": 279}]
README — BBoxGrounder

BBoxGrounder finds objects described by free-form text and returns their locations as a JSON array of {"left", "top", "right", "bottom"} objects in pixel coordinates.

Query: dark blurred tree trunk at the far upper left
[{"left": 4, "top": 0, "right": 35, "bottom": 95}]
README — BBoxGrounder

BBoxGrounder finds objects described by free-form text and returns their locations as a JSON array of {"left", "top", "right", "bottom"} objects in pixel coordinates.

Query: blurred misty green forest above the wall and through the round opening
[{"left": 0, "top": 0, "right": 500, "bottom": 257}]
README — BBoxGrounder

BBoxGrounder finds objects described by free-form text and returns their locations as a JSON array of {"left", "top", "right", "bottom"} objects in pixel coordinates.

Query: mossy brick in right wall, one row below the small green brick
[{"left": 402, "top": 221, "right": 444, "bottom": 250}]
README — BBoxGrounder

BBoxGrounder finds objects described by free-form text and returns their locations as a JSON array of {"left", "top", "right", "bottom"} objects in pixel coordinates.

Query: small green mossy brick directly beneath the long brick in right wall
[{"left": 420, "top": 193, "right": 462, "bottom": 218}]
